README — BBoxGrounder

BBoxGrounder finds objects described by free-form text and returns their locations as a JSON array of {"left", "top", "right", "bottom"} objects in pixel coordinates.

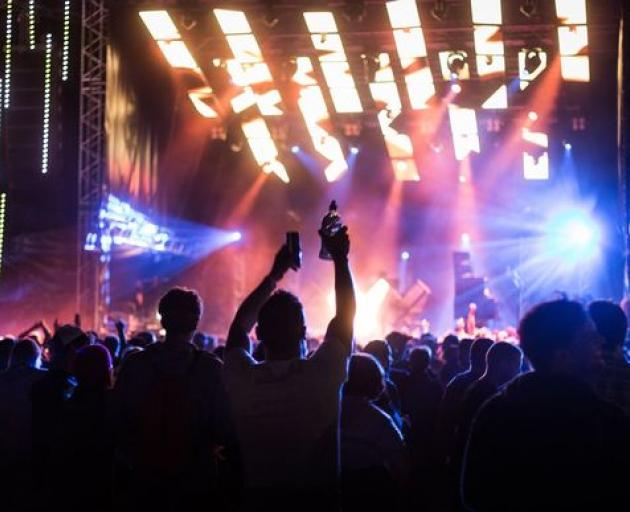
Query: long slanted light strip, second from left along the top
[{"left": 213, "top": 9, "right": 289, "bottom": 183}]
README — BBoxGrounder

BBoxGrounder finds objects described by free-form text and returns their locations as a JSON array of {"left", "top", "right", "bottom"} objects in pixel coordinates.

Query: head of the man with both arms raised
[{"left": 256, "top": 290, "right": 306, "bottom": 359}]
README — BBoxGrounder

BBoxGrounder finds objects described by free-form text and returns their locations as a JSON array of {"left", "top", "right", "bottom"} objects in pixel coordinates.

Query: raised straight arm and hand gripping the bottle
[{"left": 320, "top": 226, "right": 357, "bottom": 346}]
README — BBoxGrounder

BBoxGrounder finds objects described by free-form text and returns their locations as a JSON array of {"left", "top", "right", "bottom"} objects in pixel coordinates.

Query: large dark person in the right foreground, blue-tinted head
[{"left": 462, "top": 300, "right": 630, "bottom": 511}]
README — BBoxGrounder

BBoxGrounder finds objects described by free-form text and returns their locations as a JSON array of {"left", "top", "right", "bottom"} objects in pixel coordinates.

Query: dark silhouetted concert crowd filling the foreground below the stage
[{"left": 0, "top": 227, "right": 630, "bottom": 512}]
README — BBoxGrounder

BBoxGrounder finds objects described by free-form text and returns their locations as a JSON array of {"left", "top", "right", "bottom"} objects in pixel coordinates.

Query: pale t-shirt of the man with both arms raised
[{"left": 224, "top": 339, "right": 350, "bottom": 489}]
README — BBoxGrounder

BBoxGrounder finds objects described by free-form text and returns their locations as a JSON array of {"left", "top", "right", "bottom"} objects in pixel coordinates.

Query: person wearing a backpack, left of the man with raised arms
[{"left": 114, "top": 288, "right": 228, "bottom": 512}]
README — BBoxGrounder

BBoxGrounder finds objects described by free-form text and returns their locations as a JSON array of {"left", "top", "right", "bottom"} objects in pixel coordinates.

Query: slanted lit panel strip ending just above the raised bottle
[{"left": 291, "top": 57, "right": 348, "bottom": 181}]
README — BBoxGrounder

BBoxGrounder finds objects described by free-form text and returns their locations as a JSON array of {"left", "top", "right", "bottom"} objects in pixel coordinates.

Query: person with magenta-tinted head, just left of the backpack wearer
[{"left": 53, "top": 344, "right": 113, "bottom": 512}]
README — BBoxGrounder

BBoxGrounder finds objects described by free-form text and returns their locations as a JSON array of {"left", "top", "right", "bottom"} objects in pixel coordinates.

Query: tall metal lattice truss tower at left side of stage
[{"left": 76, "top": 0, "right": 109, "bottom": 329}]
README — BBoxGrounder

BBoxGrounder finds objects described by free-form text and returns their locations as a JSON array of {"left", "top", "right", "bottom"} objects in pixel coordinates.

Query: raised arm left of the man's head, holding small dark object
[{"left": 225, "top": 245, "right": 292, "bottom": 352}]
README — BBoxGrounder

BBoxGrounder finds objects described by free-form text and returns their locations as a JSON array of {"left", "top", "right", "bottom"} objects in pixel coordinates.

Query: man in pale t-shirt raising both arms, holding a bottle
[{"left": 225, "top": 227, "right": 356, "bottom": 512}]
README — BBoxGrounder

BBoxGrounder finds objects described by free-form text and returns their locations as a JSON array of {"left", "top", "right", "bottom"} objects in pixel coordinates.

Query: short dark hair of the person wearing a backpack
[{"left": 158, "top": 287, "right": 203, "bottom": 333}]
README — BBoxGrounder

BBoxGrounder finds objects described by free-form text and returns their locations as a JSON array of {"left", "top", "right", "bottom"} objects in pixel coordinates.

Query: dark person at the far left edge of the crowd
[{"left": 0, "top": 339, "right": 46, "bottom": 510}]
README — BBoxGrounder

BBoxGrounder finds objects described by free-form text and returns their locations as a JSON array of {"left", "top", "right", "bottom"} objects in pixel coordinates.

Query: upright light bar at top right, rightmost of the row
[{"left": 556, "top": 0, "right": 591, "bottom": 82}]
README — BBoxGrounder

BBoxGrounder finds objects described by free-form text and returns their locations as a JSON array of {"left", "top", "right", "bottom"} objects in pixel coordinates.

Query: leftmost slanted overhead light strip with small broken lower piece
[{"left": 138, "top": 11, "right": 218, "bottom": 117}]
